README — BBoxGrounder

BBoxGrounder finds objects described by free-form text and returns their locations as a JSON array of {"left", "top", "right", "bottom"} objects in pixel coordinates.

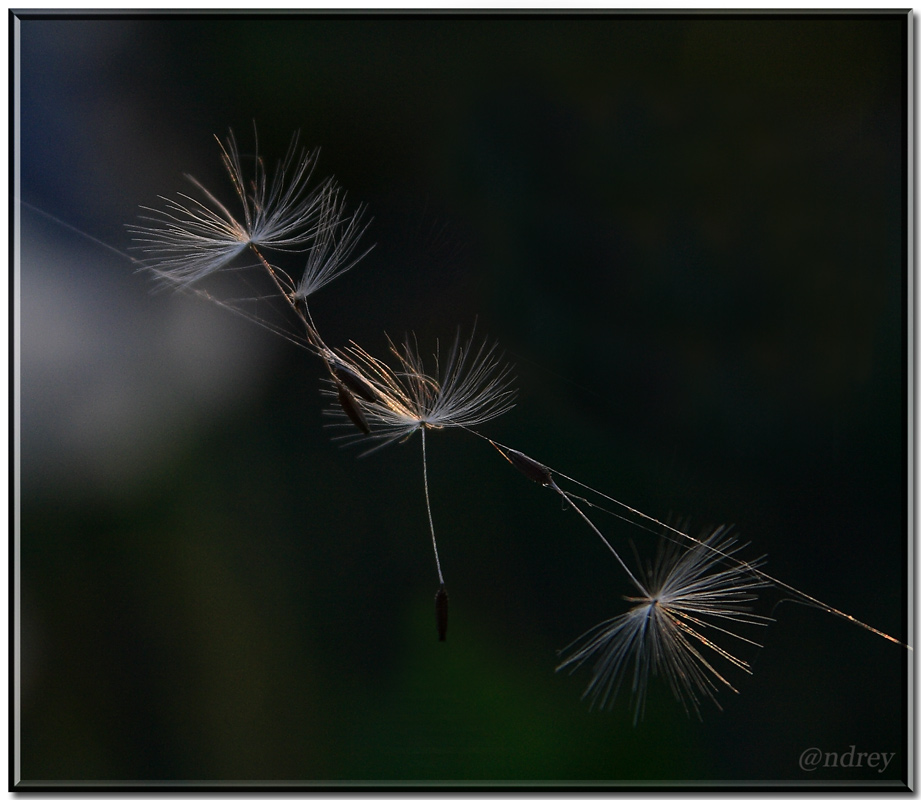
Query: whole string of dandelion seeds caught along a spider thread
[{"left": 129, "top": 132, "right": 901, "bottom": 722}]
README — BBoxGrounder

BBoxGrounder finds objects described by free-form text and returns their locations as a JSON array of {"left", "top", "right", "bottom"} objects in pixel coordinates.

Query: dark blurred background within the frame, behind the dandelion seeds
[{"left": 12, "top": 14, "right": 910, "bottom": 786}]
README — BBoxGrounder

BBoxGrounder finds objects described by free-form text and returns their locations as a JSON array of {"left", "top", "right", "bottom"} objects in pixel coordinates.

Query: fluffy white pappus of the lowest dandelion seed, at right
[{"left": 557, "top": 528, "right": 770, "bottom": 724}]
